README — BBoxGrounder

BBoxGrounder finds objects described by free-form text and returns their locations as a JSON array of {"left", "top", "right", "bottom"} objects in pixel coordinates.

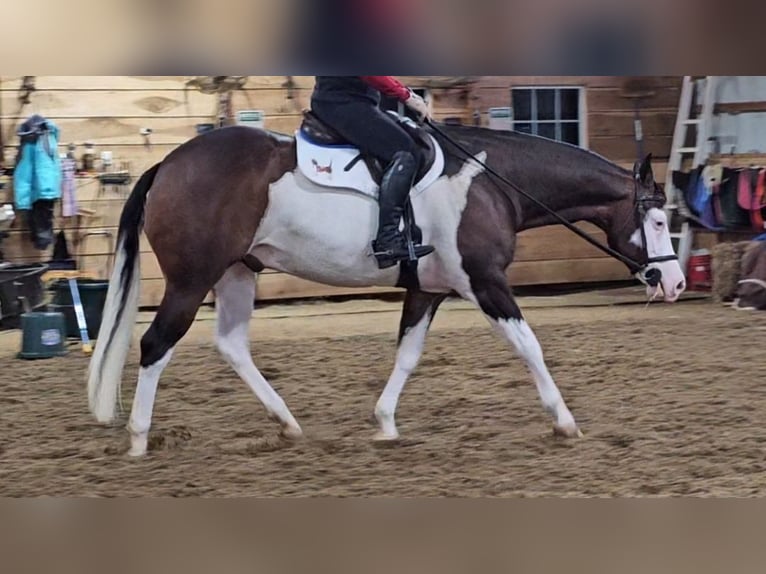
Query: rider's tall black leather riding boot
[{"left": 372, "top": 152, "right": 434, "bottom": 269}]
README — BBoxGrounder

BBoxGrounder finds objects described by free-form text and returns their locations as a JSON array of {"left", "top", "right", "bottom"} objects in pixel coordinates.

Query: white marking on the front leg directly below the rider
[{"left": 375, "top": 311, "right": 433, "bottom": 440}]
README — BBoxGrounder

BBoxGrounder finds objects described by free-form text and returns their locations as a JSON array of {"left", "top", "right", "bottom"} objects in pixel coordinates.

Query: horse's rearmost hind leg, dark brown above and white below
[{"left": 128, "top": 283, "right": 206, "bottom": 456}]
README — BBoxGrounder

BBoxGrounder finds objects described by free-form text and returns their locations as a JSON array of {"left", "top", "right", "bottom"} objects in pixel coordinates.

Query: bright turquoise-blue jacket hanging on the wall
[{"left": 13, "top": 114, "right": 61, "bottom": 210}]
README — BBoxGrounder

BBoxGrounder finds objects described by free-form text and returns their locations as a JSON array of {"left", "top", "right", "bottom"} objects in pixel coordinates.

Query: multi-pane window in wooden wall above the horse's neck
[{"left": 511, "top": 86, "right": 585, "bottom": 147}]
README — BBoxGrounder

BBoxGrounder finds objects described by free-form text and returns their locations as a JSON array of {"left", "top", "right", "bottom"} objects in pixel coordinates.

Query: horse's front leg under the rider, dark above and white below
[{"left": 375, "top": 291, "right": 446, "bottom": 441}]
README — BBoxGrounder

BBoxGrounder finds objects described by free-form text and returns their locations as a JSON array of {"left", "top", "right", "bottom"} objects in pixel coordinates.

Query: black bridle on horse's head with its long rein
[{"left": 426, "top": 119, "right": 678, "bottom": 287}]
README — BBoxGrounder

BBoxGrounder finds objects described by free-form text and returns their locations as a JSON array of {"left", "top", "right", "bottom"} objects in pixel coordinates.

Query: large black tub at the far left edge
[{"left": 0, "top": 263, "right": 48, "bottom": 330}]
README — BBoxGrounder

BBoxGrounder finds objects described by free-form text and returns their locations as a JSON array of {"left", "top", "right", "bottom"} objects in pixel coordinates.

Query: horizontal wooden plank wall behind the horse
[{"left": 0, "top": 80, "right": 680, "bottom": 306}]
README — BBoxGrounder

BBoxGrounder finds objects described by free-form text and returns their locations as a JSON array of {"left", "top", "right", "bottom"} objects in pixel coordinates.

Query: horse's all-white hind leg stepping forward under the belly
[{"left": 215, "top": 263, "right": 302, "bottom": 439}]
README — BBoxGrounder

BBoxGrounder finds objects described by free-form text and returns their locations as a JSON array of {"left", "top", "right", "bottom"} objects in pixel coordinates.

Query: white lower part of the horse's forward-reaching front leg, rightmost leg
[{"left": 491, "top": 319, "right": 582, "bottom": 437}]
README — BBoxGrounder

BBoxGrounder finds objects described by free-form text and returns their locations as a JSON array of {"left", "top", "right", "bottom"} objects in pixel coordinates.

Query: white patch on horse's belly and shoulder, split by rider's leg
[{"left": 250, "top": 152, "right": 486, "bottom": 294}]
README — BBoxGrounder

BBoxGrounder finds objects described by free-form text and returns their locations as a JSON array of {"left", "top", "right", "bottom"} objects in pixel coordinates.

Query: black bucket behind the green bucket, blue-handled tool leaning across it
[{"left": 48, "top": 279, "right": 109, "bottom": 339}]
